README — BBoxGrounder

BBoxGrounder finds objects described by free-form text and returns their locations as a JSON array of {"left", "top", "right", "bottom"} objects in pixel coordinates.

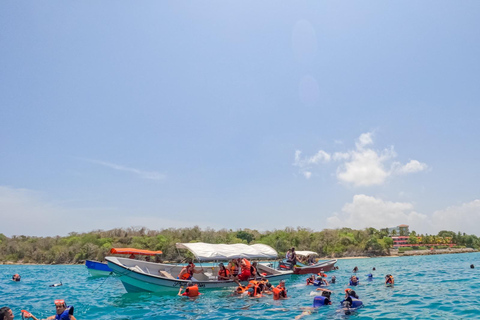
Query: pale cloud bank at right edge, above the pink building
[{"left": 432, "top": 199, "right": 480, "bottom": 235}]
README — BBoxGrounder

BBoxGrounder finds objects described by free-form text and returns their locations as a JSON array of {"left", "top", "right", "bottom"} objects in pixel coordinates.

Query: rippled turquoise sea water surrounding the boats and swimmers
[{"left": 0, "top": 253, "right": 480, "bottom": 320}]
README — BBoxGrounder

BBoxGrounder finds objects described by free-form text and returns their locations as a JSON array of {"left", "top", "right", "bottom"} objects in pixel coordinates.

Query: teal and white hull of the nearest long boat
[{"left": 106, "top": 257, "right": 292, "bottom": 293}]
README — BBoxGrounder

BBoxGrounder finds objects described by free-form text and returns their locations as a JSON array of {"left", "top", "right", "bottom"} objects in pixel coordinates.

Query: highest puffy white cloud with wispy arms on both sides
[{"left": 294, "top": 132, "right": 428, "bottom": 187}]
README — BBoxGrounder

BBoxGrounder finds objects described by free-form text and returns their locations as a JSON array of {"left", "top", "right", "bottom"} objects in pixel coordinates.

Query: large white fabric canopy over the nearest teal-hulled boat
[{"left": 176, "top": 242, "right": 278, "bottom": 261}]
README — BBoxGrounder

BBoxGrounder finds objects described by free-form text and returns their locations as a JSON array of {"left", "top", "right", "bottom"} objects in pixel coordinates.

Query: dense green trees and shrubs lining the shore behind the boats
[{"left": 0, "top": 227, "right": 480, "bottom": 264}]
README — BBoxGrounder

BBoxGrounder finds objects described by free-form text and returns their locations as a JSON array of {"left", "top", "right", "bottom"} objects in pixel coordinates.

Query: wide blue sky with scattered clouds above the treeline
[{"left": 0, "top": 0, "right": 480, "bottom": 236}]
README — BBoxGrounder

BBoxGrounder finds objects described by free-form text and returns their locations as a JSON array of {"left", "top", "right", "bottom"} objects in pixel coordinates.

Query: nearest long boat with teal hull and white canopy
[{"left": 105, "top": 242, "right": 292, "bottom": 293}]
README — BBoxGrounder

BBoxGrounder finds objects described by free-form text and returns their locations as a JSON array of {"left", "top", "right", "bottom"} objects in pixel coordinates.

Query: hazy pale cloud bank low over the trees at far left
[{"left": 0, "top": 186, "right": 206, "bottom": 237}]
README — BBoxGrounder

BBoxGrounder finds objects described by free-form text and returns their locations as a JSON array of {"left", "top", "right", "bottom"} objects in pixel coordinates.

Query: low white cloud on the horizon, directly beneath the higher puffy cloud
[{"left": 327, "top": 194, "right": 431, "bottom": 232}]
